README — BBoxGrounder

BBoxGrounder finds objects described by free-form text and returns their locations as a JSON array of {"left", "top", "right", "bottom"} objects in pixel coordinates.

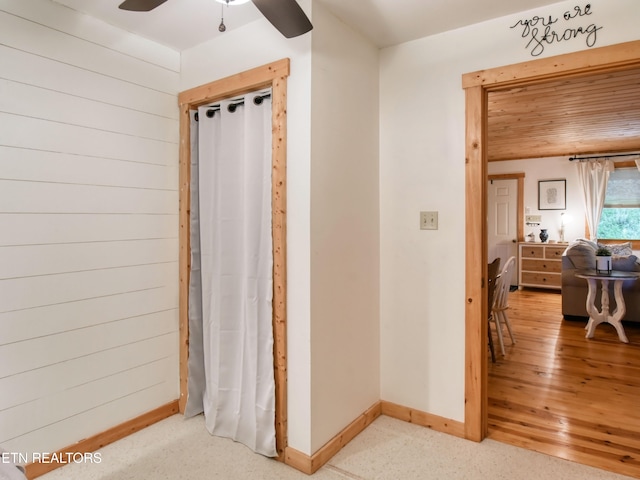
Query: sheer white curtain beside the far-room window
[{"left": 577, "top": 159, "right": 614, "bottom": 240}]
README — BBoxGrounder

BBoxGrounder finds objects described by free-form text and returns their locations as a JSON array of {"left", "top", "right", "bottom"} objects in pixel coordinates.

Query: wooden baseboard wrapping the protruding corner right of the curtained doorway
[{"left": 284, "top": 402, "right": 382, "bottom": 475}]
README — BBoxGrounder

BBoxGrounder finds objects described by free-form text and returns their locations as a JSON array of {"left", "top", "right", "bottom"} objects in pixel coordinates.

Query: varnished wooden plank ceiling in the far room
[{"left": 488, "top": 69, "right": 640, "bottom": 161}]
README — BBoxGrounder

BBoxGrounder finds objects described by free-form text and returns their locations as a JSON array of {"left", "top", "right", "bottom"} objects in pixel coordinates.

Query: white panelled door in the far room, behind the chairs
[{"left": 487, "top": 179, "right": 518, "bottom": 284}]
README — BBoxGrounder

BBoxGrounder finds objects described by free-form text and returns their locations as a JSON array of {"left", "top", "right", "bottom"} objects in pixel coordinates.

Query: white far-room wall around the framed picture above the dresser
[{"left": 488, "top": 157, "right": 585, "bottom": 242}]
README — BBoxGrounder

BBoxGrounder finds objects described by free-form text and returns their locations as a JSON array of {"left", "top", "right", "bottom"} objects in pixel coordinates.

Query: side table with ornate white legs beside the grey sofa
[{"left": 576, "top": 270, "right": 638, "bottom": 343}]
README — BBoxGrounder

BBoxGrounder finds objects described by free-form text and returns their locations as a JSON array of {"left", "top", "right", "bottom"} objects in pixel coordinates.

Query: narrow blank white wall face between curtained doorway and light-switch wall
[{"left": 311, "top": 3, "right": 380, "bottom": 452}]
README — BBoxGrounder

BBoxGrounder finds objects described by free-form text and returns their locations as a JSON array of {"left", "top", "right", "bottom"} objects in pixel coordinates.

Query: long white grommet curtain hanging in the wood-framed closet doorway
[{"left": 185, "top": 92, "right": 277, "bottom": 456}]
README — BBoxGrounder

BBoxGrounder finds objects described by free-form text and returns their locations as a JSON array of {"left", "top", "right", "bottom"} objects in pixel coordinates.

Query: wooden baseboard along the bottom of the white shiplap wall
[{"left": 26, "top": 400, "right": 178, "bottom": 479}]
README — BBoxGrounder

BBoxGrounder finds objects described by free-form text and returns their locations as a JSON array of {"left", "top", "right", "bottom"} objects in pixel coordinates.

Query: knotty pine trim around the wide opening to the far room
[{"left": 462, "top": 40, "right": 640, "bottom": 441}]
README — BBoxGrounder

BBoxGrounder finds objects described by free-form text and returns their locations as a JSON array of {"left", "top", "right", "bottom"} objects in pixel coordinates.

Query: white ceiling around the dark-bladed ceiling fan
[{"left": 53, "top": 0, "right": 557, "bottom": 51}]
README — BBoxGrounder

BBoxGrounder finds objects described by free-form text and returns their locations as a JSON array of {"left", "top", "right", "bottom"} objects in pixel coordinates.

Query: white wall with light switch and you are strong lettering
[{"left": 380, "top": 0, "right": 640, "bottom": 421}]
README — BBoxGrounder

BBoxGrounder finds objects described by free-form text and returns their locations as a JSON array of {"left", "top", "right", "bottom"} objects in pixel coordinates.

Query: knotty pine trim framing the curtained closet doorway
[{"left": 178, "top": 58, "right": 290, "bottom": 461}]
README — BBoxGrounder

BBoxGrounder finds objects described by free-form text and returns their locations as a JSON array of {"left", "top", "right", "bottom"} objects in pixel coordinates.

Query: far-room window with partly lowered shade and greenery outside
[{"left": 598, "top": 168, "right": 640, "bottom": 240}]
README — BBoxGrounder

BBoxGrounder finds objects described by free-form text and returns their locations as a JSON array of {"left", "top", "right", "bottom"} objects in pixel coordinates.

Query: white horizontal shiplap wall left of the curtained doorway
[{"left": 0, "top": 0, "right": 180, "bottom": 453}]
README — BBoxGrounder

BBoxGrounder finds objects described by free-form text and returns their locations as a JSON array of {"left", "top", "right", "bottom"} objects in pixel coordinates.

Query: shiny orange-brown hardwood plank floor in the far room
[{"left": 489, "top": 289, "right": 640, "bottom": 478}]
